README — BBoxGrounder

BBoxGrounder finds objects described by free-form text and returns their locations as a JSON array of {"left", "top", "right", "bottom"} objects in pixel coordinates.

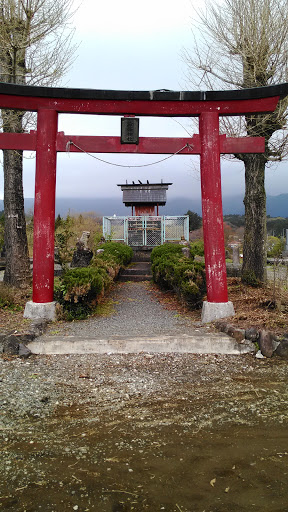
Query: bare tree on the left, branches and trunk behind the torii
[{"left": 0, "top": 0, "right": 75, "bottom": 287}]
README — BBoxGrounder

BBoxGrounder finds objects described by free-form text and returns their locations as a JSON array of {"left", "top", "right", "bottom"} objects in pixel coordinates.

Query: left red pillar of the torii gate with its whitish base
[{"left": 24, "top": 109, "right": 58, "bottom": 319}]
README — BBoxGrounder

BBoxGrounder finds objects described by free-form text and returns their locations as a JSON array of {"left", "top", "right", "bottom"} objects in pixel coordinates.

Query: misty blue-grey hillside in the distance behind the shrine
[{"left": 0, "top": 194, "right": 288, "bottom": 217}]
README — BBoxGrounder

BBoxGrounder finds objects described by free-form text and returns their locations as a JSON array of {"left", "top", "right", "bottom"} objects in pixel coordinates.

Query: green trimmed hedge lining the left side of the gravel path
[{"left": 54, "top": 242, "right": 133, "bottom": 320}]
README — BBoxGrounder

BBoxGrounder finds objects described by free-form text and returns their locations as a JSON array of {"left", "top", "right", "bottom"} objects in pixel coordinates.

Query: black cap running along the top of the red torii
[{"left": 0, "top": 82, "right": 288, "bottom": 101}]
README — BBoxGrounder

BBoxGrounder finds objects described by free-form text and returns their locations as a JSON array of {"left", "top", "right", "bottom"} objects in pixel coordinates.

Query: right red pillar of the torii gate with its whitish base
[{"left": 199, "top": 112, "right": 234, "bottom": 322}]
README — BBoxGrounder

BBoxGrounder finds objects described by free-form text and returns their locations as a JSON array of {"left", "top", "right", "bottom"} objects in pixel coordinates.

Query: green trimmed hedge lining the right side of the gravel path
[{"left": 151, "top": 242, "right": 206, "bottom": 309}]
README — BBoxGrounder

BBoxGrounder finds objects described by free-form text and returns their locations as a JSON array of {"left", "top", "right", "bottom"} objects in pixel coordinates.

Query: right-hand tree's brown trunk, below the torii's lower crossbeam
[{"left": 242, "top": 154, "right": 267, "bottom": 286}]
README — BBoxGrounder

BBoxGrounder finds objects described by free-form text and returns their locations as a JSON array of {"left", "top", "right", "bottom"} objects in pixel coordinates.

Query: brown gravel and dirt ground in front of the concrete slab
[{"left": 0, "top": 354, "right": 288, "bottom": 512}]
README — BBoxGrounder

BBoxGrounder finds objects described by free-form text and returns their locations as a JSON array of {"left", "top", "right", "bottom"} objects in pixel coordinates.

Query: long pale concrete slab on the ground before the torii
[{"left": 27, "top": 334, "right": 255, "bottom": 355}]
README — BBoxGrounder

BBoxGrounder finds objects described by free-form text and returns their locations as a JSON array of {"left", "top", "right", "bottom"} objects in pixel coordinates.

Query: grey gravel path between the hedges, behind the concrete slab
[{"left": 48, "top": 282, "right": 207, "bottom": 339}]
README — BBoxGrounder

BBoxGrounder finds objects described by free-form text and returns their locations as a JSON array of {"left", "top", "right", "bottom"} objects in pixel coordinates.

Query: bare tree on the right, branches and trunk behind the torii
[{"left": 183, "top": 0, "right": 288, "bottom": 284}]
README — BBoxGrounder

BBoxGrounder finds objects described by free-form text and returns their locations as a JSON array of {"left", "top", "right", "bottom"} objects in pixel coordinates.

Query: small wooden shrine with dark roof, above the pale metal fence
[{"left": 117, "top": 180, "right": 172, "bottom": 216}]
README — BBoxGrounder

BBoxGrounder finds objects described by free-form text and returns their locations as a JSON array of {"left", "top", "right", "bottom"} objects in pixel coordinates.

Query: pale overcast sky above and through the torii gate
[{"left": 0, "top": 0, "right": 288, "bottom": 204}]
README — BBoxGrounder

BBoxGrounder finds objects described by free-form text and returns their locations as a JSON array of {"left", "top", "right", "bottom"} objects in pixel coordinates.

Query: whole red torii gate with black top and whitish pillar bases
[{"left": 0, "top": 83, "right": 288, "bottom": 322}]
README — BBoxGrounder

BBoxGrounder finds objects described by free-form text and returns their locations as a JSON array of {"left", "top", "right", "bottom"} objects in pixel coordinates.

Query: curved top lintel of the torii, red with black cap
[{"left": 0, "top": 83, "right": 288, "bottom": 117}]
